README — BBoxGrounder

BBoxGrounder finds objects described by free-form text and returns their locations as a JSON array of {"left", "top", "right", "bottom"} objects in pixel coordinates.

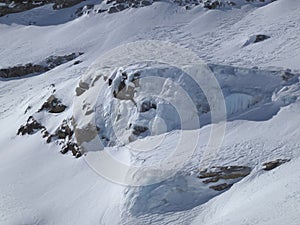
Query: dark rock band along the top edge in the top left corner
[{"left": 0, "top": 0, "right": 84, "bottom": 16}]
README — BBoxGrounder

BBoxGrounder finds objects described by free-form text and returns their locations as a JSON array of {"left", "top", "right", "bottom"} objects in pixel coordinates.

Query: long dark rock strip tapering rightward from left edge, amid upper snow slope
[{"left": 0, "top": 53, "right": 83, "bottom": 78}]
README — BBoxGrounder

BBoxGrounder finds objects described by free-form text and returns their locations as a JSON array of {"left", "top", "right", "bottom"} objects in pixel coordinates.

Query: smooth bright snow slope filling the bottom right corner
[{"left": 193, "top": 159, "right": 300, "bottom": 225}]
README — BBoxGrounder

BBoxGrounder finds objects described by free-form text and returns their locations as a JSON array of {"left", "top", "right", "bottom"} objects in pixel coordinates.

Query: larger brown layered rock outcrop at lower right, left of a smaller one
[{"left": 198, "top": 166, "right": 252, "bottom": 191}]
